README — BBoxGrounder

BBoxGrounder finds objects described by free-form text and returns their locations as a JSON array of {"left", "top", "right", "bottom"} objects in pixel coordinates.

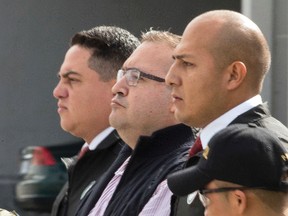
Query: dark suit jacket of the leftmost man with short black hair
[{"left": 51, "top": 130, "right": 124, "bottom": 216}]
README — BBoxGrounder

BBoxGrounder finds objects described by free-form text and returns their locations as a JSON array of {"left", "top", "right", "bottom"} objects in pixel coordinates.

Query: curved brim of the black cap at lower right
[{"left": 167, "top": 166, "right": 213, "bottom": 196}]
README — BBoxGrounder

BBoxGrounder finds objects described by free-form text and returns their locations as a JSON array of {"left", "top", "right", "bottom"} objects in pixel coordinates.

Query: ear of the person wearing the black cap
[{"left": 230, "top": 190, "right": 248, "bottom": 215}]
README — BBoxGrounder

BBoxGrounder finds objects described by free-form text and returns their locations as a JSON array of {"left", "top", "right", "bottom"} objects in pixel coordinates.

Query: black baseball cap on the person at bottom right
[{"left": 168, "top": 124, "right": 288, "bottom": 196}]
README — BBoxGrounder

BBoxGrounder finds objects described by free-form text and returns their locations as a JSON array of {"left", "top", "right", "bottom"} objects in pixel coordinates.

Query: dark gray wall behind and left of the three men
[{"left": 0, "top": 0, "right": 240, "bottom": 212}]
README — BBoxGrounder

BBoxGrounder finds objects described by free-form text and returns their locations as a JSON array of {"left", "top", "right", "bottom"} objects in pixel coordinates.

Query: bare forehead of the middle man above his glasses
[{"left": 123, "top": 42, "right": 173, "bottom": 75}]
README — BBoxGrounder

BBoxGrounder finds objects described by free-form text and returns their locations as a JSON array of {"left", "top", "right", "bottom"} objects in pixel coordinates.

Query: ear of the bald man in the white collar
[{"left": 227, "top": 61, "right": 247, "bottom": 90}]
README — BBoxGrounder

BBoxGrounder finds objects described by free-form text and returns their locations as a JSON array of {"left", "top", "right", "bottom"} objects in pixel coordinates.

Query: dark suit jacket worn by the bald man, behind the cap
[{"left": 168, "top": 104, "right": 288, "bottom": 216}]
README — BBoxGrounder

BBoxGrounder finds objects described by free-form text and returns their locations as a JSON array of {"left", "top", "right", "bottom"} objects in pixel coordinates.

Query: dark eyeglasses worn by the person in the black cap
[{"left": 198, "top": 187, "right": 265, "bottom": 208}]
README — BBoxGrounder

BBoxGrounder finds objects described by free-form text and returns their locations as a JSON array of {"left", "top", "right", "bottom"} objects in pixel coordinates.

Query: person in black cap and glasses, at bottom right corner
[{"left": 168, "top": 124, "right": 288, "bottom": 216}]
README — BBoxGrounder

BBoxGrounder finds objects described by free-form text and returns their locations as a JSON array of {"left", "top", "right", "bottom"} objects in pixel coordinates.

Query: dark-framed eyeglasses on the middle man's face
[{"left": 117, "top": 68, "right": 165, "bottom": 86}]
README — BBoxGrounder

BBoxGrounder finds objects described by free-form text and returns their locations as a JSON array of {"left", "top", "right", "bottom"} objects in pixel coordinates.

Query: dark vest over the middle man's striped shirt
[{"left": 76, "top": 124, "right": 194, "bottom": 216}]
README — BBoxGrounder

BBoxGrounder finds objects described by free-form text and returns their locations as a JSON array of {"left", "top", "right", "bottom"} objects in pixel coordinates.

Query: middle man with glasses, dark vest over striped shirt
[{"left": 77, "top": 30, "right": 194, "bottom": 216}]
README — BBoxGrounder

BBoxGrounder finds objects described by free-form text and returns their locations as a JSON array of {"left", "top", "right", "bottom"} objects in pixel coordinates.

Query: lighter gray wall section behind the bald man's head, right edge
[{"left": 241, "top": 0, "right": 288, "bottom": 125}]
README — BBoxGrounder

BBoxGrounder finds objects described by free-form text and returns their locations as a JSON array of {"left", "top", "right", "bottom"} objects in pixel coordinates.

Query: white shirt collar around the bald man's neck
[{"left": 200, "top": 95, "right": 262, "bottom": 149}]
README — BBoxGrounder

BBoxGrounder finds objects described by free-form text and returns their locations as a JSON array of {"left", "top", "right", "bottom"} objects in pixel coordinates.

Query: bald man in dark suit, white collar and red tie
[{"left": 165, "top": 10, "right": 288, "bottom": 216}]
